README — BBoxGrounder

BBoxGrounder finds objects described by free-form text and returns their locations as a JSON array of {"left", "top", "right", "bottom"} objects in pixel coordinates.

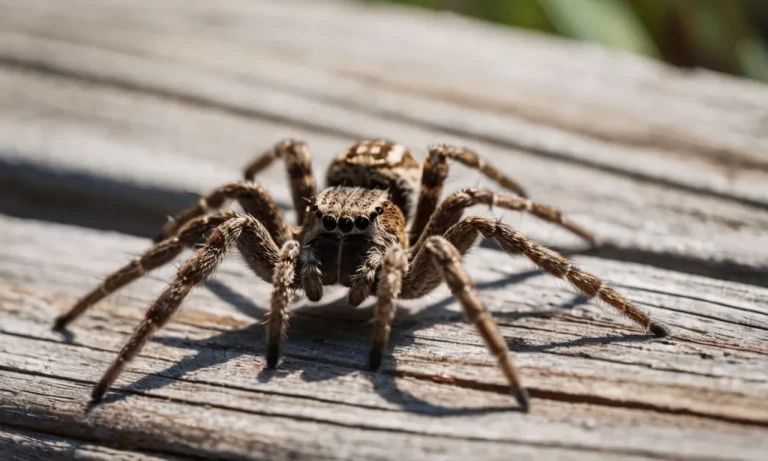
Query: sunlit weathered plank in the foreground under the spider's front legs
[{"left": 0, "top": 218, "right": 768, "bottom": 459}]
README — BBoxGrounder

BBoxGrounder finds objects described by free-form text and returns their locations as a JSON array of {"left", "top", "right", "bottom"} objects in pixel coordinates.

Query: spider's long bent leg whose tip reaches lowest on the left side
[{"left": 91, "top": 215, "right": 279, "bottom": 402}]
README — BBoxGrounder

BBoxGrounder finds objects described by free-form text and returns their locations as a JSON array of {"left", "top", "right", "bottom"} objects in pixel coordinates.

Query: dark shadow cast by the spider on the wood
[{"left": 93, "top": 264, "right": 648, "bottom": 416}]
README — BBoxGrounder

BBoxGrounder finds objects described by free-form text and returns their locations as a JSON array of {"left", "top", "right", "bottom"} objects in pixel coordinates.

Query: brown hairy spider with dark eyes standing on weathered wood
[{"left": 54, "top": 140, "right": 670, "bottom": 412}]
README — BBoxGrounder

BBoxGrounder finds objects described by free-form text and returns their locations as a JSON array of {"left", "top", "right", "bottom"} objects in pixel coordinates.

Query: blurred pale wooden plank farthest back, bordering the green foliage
[{"left": 4, "top": 0, "right": 768, "bottom": 206}]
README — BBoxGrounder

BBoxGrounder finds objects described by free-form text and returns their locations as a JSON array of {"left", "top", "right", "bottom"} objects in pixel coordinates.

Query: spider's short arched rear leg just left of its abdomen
[{"left": 245, "top": 139, "right": 317, "bottom": 225}]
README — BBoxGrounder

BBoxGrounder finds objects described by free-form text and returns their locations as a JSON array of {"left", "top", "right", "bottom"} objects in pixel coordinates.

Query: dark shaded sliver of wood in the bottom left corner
[{"left": 0, "top": 427, "right": 177, "bottom": 461}]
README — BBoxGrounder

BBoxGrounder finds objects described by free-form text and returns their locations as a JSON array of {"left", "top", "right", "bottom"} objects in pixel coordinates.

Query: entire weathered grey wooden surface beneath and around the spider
[{"left": 0, "top": 0, "right": 768, "bottom": 460}]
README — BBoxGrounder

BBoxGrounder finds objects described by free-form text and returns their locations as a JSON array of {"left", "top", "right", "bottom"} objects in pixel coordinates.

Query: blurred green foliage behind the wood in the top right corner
[{"left": 362, "top": 0, "right": 768, "bottom": 82}]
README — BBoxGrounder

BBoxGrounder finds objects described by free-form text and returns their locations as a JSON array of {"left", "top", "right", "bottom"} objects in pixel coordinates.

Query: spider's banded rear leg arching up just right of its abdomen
[{"left": 410, "top": 145, "right": 526, "bottom": 245}]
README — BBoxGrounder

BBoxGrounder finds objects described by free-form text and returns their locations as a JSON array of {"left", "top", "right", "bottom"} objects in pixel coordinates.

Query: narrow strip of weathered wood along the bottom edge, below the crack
[{"left": 0, "top": 372, "right": 688, "bottom": 460}]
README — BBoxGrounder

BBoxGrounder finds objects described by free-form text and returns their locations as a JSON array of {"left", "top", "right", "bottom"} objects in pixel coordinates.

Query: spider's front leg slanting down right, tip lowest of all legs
[{"left": 403, "top": 236, "right": 529, "bottom": 412}]
